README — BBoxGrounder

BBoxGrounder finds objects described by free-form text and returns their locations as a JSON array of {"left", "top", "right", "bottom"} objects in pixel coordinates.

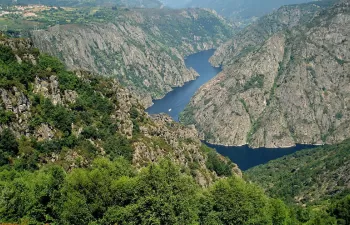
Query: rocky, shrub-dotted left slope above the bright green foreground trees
[{"left": 0, "top": 37, "right": 240, "bottom": 186}]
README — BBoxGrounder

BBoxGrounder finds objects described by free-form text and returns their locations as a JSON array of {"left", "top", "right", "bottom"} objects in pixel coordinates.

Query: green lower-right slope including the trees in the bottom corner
[{"left": 245, "top": 140, "right": 350, "bottom": 225}]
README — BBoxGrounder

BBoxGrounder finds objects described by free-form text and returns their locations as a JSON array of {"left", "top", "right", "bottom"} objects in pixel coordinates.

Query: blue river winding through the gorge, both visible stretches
[{"left": 146, "top": 50, "right": 314, "bottom": 170}]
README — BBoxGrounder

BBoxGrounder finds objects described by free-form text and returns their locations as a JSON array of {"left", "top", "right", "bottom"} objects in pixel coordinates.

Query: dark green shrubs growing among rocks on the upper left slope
[{"left": 0, "top": 36, "right": 147, "bottom": 169}]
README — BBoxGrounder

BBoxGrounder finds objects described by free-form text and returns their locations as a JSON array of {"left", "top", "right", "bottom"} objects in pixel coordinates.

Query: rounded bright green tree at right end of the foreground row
[{"left": 200, "top": 177, "right": 271, "bottom": 225}]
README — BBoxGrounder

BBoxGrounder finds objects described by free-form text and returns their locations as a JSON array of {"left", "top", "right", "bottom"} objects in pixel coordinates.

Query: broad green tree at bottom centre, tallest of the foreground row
[{"left": 102, "top": 161, "right": 198, "bottom": 224}]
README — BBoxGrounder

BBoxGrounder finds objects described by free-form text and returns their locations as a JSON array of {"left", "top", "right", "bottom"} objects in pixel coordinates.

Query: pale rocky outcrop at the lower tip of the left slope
[{"left": 133, "top": 114, "right": 242, "bottom": 186}]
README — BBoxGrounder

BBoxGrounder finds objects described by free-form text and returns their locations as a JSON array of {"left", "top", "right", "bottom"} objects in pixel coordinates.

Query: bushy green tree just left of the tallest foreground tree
[{"left": 59, "top": 158, "right": 134, "bottom": 224}]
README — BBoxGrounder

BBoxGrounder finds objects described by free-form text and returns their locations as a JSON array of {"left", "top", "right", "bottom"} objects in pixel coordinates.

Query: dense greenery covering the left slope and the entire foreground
[{"left": 0, "top": 33, "right": 350, "bottom": 225}]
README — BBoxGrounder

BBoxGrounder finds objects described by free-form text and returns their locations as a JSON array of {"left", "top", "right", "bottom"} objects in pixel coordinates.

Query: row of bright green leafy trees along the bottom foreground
[{"left": 0, "top": 158, "right": 288, "bottom": 224}]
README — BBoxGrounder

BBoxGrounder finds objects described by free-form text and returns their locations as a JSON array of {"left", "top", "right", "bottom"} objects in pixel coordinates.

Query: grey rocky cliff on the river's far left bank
[{"left": 31, "top": 9, "right": 231, "bottom": 106}]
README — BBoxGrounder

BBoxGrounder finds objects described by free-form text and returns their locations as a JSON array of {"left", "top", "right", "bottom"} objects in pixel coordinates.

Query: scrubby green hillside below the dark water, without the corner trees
[{"left": 245, "top": 140, "right": 350, "bottom": 204}]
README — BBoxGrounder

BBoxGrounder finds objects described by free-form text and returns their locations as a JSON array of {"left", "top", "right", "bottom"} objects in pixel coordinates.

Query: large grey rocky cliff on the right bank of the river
[{"left": 182, "top": 2, "right": 350, "bottom": 148}]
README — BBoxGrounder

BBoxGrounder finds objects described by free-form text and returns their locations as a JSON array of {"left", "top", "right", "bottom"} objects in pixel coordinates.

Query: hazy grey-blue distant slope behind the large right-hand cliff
[{"left": 210, "top": 0, "right": 335, "bottom": 67}]
